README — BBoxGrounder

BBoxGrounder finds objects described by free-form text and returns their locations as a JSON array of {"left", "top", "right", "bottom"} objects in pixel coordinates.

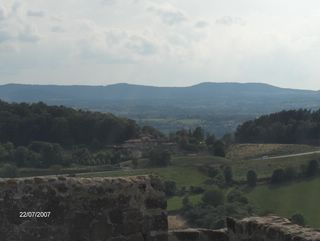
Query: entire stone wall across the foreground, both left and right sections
[{"left": 0, "top": 176, "right": 320, "bottom": 241}]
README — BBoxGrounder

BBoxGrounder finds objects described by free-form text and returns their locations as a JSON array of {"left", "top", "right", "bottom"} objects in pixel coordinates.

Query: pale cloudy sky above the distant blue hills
[{"left": 0, "top": 0, "right": 320, "bottom": 90}]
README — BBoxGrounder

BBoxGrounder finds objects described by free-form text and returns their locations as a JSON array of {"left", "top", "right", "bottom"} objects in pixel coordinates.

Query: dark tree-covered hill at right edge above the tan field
[{"left": 235, "top": 109, "right": 320, "bottom": 145}]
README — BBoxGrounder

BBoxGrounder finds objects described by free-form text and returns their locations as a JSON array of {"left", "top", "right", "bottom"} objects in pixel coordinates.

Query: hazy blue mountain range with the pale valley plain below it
[{"left": 0, "top": 83, "right": 320, "bottom": 135}]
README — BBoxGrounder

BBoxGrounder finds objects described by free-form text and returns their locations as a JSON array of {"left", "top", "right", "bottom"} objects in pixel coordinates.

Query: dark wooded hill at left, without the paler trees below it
[{"left": 0, "top": 101, "right": 139, "bottom": 147}]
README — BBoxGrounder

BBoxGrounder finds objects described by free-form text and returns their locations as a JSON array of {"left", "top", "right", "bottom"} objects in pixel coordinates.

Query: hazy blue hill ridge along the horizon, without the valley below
[{"left": 0, "top": 82, "right": 320, "bottom": 105}]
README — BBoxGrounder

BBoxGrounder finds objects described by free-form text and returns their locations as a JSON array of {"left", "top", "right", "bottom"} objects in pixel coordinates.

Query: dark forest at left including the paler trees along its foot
[{"left": 0, "top": 101, "right": 144, "bottom": 171}]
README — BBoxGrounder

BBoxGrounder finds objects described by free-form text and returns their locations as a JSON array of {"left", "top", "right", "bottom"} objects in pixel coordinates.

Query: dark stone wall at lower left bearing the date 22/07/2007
[{"left": 0, "top": 176, "right": 168, "bottom": 241}]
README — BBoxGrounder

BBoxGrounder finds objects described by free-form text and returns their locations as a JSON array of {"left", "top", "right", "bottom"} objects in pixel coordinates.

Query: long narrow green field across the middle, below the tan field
[{"left": 80, "top": 153, "right": 320, "bottom": 183}]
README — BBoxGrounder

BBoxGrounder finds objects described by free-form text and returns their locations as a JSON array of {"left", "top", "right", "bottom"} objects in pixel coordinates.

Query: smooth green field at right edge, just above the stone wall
[{"left": 248, "top": 177, "right": 320, "bottom": 228}]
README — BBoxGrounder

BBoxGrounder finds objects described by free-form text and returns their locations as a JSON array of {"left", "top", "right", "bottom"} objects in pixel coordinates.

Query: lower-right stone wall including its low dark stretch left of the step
[{"left": 169, "top": 216, "right": 320, "bottom": 241}]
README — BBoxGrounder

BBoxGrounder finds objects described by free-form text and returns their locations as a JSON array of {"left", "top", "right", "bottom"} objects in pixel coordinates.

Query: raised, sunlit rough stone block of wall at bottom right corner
[{"left": 227, "top": 216, "right": 320, "bottom": 241}]
